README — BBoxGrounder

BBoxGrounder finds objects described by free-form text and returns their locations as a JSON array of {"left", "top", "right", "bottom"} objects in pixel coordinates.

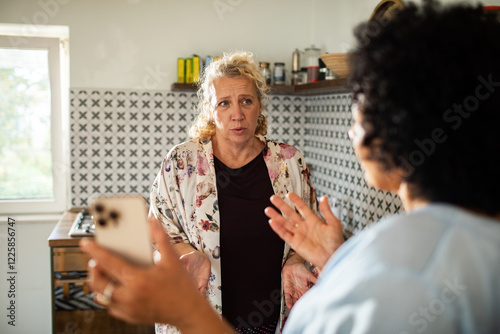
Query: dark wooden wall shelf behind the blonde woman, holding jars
[{"left": 171, "top": 78, "right": 351, "bottom": 95}]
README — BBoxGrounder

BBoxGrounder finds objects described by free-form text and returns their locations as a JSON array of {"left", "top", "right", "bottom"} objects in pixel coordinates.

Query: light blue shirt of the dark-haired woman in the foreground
[{"left": 284, "top": 204, "right": 500, "bottom": 334}]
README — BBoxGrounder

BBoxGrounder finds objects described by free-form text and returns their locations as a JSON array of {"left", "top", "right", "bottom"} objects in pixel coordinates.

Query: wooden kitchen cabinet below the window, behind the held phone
[{"left": 48, "top": 210, "right": 154, "bottom": 334}]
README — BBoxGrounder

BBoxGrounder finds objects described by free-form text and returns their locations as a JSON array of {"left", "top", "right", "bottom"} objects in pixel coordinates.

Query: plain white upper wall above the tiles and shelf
[{"left": 0, "top": 0, "right": 492, "bottom": 89}]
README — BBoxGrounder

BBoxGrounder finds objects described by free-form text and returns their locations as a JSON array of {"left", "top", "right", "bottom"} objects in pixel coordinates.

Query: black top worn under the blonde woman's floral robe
[{"left": 214, "top": 154, "right": 284, "bottom": 333}]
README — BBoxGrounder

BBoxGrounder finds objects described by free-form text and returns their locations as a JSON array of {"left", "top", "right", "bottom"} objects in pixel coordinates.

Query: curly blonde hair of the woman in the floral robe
[{"left": 189, "top": 52, "right": 269, "bottom": 139}]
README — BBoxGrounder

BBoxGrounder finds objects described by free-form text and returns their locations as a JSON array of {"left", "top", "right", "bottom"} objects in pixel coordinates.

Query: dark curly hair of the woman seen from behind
[{"left": 349, "top": 1, "right": 500, "bottom": 215}]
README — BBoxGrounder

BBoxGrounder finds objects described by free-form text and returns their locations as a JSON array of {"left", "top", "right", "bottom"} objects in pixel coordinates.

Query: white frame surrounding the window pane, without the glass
[{"left": 0, "top": 24, "right": 70, "bottom": 217}]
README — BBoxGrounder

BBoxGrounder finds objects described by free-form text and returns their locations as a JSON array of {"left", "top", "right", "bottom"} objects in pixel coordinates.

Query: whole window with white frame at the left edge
[{"left": 0, "top": 24, "right": 69, "bottom": 214}]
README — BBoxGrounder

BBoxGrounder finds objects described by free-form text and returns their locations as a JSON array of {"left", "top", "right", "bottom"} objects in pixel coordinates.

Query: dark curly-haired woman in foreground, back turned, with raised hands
[{"left": 80, "top": 1, "right": 500, "bottom": 334}]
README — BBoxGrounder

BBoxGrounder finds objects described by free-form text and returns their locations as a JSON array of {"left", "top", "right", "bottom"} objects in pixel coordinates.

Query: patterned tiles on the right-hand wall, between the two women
[{"left": 304, "top": 94, "right": 401, "bottom": 234}]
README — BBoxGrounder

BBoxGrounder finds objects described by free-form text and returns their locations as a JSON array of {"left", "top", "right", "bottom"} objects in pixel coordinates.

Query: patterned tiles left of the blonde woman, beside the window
[{"left": 71, "top": 89, "right": 197, "bottom": 206}]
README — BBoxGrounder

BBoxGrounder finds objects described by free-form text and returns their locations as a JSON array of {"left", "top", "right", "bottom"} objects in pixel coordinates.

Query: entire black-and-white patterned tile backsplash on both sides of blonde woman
[{"left": 71, "top": 88, "right": 402, "bottom": 233}]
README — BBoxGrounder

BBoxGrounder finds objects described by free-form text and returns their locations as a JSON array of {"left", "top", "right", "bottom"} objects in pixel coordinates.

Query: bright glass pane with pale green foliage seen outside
[{"left": 0, "top": 49, "right": 53, "bottom": 200}]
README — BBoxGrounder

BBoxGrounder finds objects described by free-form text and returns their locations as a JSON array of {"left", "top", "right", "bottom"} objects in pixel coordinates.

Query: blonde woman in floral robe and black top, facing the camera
[{"left": 151, "top": 52, "right": 317, "bottom": 333}]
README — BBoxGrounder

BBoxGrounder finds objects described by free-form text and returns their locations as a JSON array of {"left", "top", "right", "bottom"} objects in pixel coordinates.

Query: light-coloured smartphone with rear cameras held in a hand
[{"left": 89, "top": 195, "right": 153, "bottom": 266}]
